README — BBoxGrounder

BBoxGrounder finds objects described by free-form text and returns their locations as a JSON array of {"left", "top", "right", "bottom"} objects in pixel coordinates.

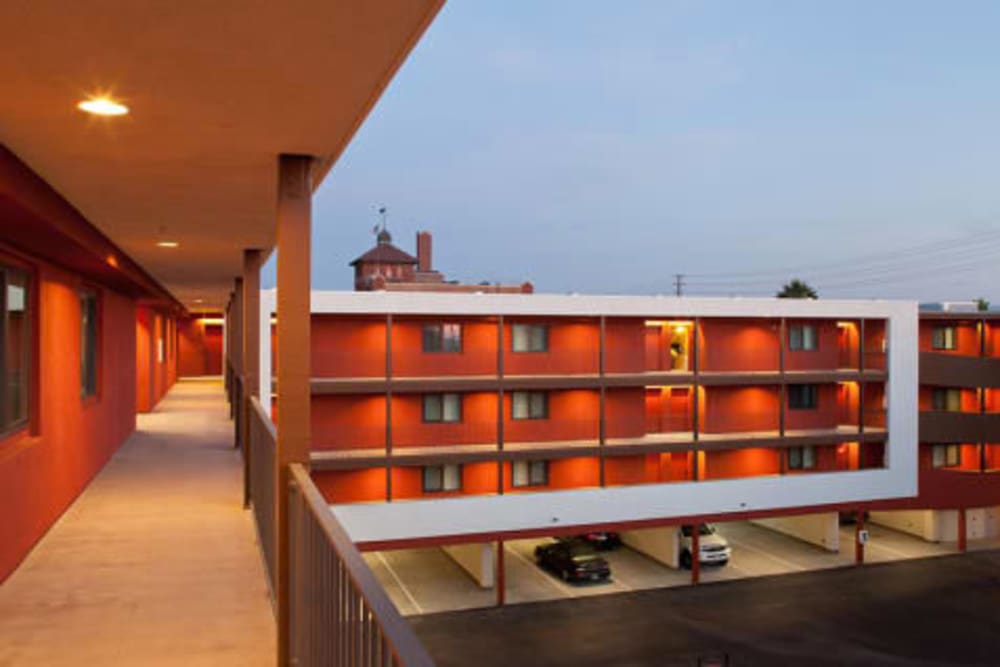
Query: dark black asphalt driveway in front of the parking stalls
[{"left": 411, "top": 551, "right": 1000, "bottom": 667}]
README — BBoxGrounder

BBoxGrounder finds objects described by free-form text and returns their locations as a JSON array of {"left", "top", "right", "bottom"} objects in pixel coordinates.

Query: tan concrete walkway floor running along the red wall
[{"left": 0, "top": 381, "right": 275, "bottom": 666}]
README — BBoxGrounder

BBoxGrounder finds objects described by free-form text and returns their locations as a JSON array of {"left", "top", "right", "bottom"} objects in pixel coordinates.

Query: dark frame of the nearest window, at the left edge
[{"left": 0, "top": 264, "right": 32, "bottom": 440}]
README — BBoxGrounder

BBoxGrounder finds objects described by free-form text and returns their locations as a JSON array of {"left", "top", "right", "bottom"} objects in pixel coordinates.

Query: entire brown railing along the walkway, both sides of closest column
[{"left": 243, "top": 381, "right": 434, "bottom": 667}]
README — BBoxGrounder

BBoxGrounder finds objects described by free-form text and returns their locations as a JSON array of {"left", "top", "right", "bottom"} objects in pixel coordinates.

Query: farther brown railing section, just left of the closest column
[{"left": 244, "top": 397, "right": 278, "bottom": 599}]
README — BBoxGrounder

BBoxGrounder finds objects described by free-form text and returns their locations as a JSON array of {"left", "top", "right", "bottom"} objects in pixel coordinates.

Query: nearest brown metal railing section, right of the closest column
[{"left": 288, "top": 464, "right": 434, "bottom": 667}]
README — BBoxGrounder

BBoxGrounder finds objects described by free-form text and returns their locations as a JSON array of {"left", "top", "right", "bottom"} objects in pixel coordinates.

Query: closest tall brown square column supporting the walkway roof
[{"left": 274, "top": 155, "right": 313, "bottom": 666}]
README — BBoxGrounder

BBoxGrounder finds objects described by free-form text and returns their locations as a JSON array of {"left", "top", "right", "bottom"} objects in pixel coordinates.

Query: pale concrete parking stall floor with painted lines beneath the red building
[{"left": 365, "top": 521, "right": 954, "bottom": 616}]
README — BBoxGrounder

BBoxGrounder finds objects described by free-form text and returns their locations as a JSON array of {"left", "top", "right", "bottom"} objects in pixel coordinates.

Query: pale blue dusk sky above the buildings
[{"left": 266, "top": 0, "right": 1000, "bottom": 303}]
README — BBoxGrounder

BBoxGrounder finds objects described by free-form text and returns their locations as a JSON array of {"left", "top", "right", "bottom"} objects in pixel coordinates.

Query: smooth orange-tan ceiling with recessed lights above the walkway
[{"left": 0, "top": 0, "right": 443, "bottom": 308}]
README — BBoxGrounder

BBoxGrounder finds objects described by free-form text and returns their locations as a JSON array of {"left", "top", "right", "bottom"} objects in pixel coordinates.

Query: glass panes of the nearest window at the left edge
[{"left": 0, "top": 266, "right": 31, "bottom": 431}]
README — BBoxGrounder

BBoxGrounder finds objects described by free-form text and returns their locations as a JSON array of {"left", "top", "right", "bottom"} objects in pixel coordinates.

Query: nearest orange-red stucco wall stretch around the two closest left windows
[{"left": 0, "top": 265, "right": 136, "bottom": 581}]
